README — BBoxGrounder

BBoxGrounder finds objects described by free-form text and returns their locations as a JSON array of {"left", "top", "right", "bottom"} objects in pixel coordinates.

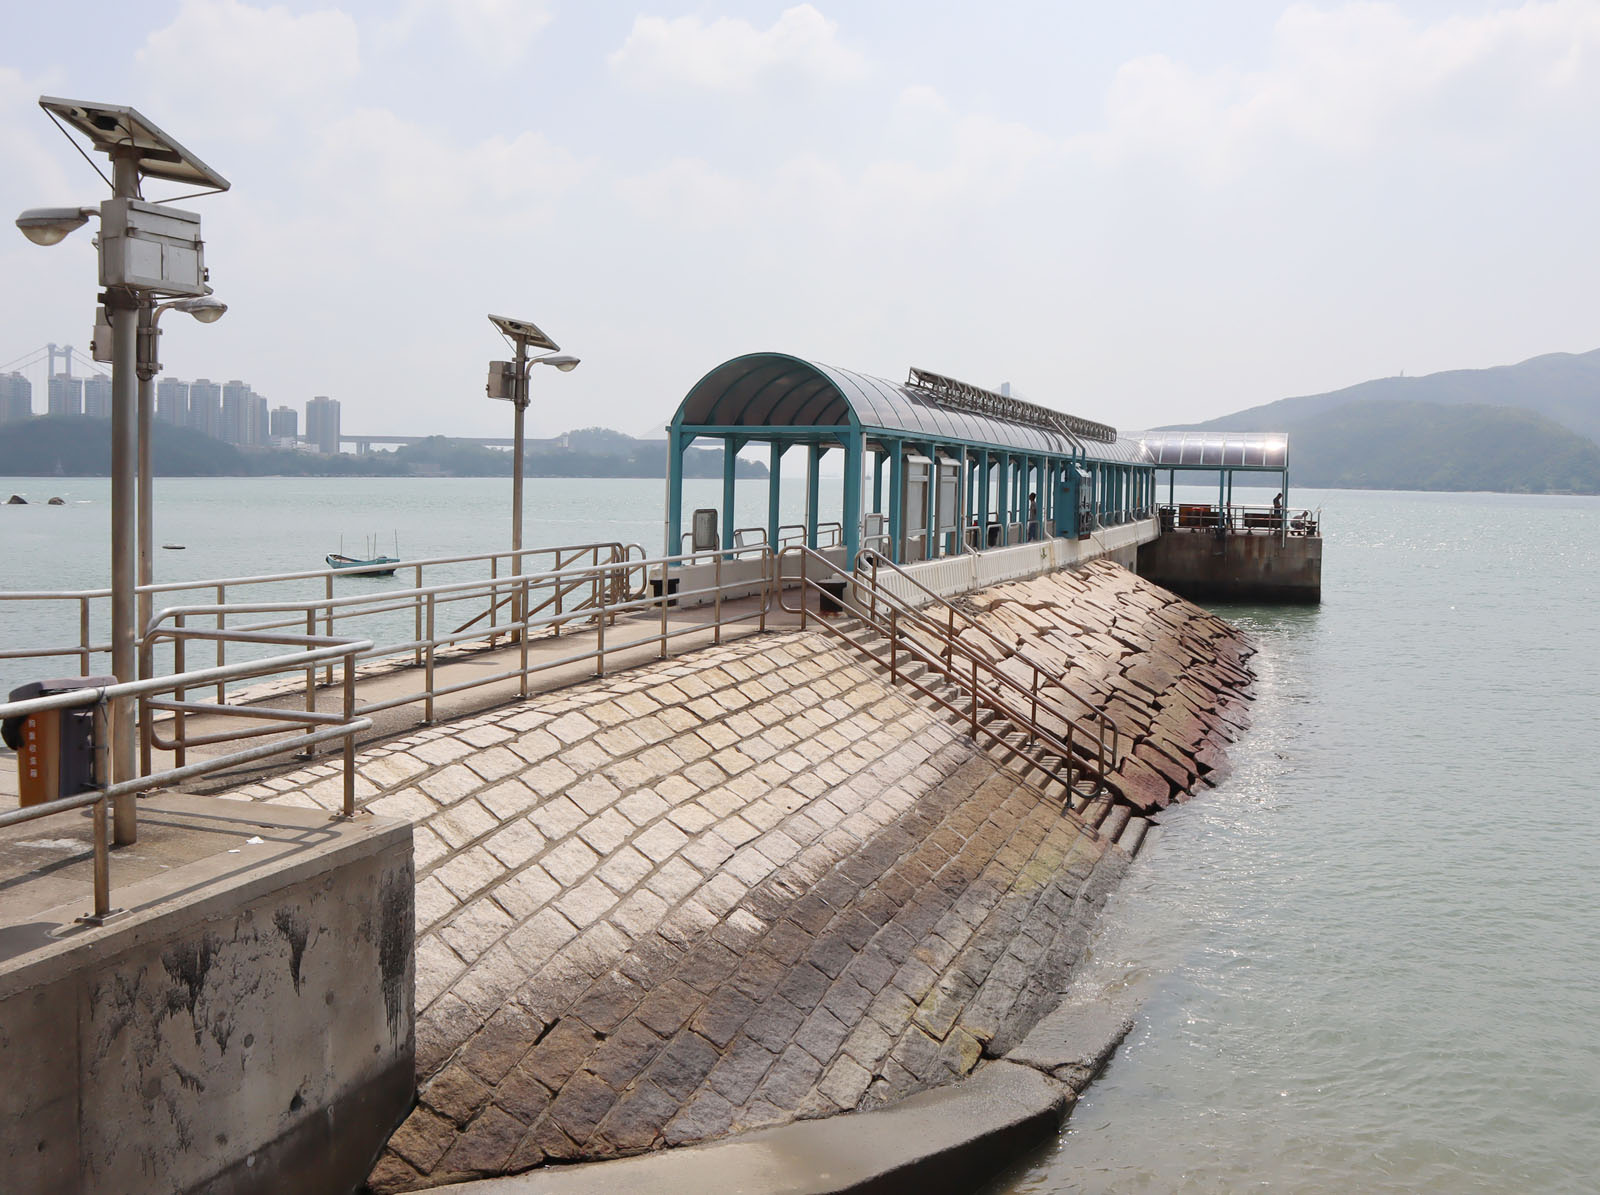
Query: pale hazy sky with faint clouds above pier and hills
[{"left": 0, "top": 0, "right": 1600, "bottom": 435}]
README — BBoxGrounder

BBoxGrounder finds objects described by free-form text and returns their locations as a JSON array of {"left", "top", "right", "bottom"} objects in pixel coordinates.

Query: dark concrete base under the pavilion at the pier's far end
[{"left": 1138, "top": 531, "right": 1322, "bottom": 601}]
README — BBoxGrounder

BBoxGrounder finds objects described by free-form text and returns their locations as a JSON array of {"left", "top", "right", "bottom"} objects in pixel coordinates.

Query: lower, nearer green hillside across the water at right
[{"left": 1280, "top": 400, "right": 1600, "bottom": 494}]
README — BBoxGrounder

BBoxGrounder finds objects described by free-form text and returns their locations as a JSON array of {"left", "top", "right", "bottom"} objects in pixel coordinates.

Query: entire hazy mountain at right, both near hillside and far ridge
[{"left": 1164, "top": 349, "right": 1600, "bottom": 494}]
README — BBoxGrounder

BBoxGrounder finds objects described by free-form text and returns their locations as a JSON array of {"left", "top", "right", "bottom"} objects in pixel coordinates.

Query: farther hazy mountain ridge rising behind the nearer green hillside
[{"left": 1190, "top": 349, "right": 1600, "bottom": 443}]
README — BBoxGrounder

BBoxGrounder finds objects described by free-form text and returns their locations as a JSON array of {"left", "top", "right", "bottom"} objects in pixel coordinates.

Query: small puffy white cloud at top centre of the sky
[{"left": 610, "top": 5, "right": 867, "bottom": 91}]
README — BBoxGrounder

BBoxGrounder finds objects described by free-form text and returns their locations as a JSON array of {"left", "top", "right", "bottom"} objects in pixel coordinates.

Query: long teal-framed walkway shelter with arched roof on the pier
[{"left": 666, "top": 354, "right": 1155, "bottom": 582}]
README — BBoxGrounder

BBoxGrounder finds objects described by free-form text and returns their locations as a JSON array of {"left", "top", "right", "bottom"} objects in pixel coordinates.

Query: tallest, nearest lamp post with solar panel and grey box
[{"left": 16, "top": 96, "right": 229, "bottom": 845}]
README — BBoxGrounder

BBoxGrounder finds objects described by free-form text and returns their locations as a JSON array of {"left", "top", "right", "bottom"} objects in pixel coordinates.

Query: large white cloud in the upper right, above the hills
[{"left": 1082, "top": 0, "right": 1600, "bottom": 182}]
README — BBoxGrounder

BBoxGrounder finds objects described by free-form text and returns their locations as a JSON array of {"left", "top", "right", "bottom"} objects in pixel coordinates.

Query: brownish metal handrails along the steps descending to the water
[{"left": 778, "top": 547, "right": 1118, "bottom": 797}]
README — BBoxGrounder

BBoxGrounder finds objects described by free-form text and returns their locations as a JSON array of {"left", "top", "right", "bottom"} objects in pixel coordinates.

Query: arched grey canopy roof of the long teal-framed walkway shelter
[{"left": 672, "top": 354, "right": 1094, "bottom": 459}]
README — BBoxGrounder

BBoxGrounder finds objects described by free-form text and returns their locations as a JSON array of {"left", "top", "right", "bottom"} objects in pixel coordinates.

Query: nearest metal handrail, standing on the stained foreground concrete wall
[{"left": 0, "top": 637, "right": 373, "bottom": 925}]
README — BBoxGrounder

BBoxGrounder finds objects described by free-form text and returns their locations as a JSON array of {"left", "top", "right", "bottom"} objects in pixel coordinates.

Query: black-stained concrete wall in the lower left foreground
[{"left": 0, "top": 798, "right": 414, "bottom": 1195}]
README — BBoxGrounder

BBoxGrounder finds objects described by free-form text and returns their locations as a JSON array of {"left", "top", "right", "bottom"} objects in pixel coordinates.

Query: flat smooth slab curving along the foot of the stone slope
[{"left": 438, "top": 1062, "right": 1075, "bottom": 1195}]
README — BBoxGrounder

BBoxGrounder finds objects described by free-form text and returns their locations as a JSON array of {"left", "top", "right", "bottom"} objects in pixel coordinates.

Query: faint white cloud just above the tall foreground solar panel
[{"left": 134, "top": 0, "right": 362, "bottom": 141}]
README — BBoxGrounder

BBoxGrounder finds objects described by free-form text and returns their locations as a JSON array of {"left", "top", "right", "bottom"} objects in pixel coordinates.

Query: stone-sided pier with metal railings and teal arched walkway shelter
[{"left": 0, "top": 354, "right": 1273, "bottom": 1192}]
